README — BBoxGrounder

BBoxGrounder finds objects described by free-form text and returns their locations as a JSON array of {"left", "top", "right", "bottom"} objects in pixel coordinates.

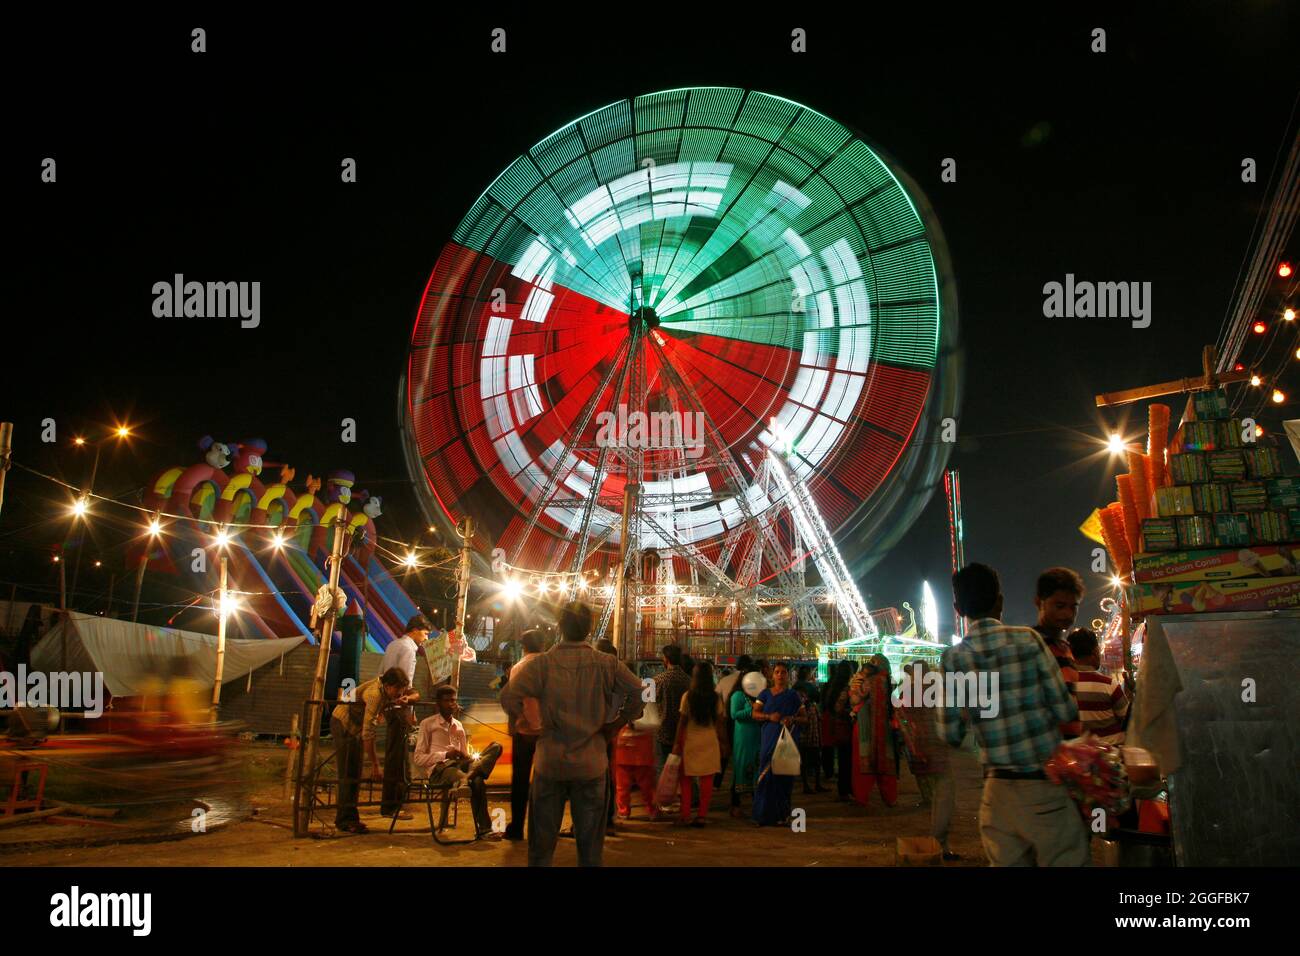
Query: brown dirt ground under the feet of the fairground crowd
[{"left": 0, "top": 753, "right": 1034, "bottom": 866}]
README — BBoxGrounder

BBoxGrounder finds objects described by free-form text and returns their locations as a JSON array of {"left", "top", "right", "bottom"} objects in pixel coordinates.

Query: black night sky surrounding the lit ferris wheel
[{"left": 0, "top": 7, "right": 1300, "bottom": 639}]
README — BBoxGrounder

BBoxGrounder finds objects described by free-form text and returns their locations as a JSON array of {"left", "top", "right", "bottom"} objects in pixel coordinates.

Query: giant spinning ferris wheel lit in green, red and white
[{"left": 403, "top": 87, "right": 958, "bottom": 642}]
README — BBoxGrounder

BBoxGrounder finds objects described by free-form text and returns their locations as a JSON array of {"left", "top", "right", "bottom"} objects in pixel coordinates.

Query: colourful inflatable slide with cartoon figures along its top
[{"left": 137, "top": 437, "right": 417, "bottom": 650}]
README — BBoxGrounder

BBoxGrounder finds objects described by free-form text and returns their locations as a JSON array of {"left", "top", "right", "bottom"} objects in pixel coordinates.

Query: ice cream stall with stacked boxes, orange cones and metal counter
[{"left": 1100, "top": 389, "right": 1300, "bottom": 866}]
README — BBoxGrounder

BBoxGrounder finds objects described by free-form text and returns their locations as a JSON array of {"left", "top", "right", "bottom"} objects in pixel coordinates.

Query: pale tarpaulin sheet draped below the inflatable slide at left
[{"left": 29, "top": 611, "right": 307, "bottom": 697}]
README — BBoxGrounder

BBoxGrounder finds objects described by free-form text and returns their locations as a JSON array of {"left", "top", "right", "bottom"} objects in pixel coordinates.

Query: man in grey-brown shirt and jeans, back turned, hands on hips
[{"left": 501, "top": 601, "right": 645, "bottom": 866}]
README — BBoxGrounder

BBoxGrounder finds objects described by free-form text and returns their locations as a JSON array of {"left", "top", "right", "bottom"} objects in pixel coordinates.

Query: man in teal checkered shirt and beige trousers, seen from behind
[{"left": 939, "top": 564, "right": 1089, "bottom": 866}]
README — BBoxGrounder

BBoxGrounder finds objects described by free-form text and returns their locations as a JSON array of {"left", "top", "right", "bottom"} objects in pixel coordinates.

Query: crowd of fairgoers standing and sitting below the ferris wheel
[{"left": 332, "top": 564, "right": 1128, "bottom": 866}]
